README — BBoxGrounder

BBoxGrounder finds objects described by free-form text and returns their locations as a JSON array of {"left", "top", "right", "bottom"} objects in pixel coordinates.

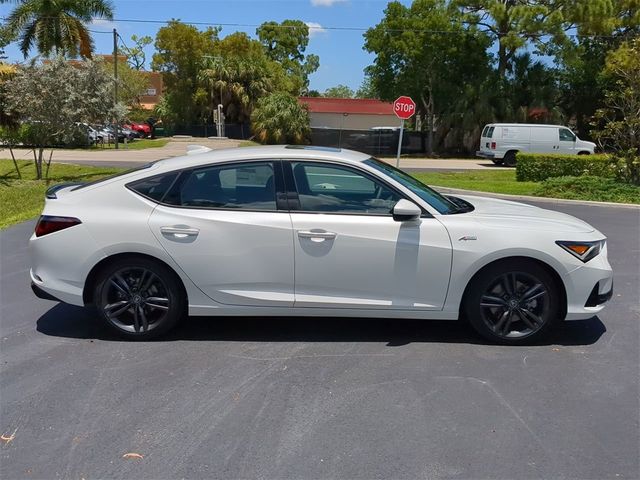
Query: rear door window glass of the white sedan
[{"left": 164, "top": 162, "right": 277, "bottom": 210}]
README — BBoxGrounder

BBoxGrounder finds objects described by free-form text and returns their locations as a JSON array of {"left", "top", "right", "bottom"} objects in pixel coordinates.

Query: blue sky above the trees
[{"left": 0, "top": 0, "right": 408, "bottom": 92}]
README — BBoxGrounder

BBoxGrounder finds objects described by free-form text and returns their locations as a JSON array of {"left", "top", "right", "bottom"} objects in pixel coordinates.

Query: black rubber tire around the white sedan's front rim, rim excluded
[{"left": 463, "top": 259, "right": 561, "bottom": 345}]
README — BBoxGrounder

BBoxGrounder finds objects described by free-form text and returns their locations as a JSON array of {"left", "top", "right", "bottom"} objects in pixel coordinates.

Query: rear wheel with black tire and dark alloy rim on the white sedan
[{"left": 93, "top": 257, "right": 186, "bottom": 340}]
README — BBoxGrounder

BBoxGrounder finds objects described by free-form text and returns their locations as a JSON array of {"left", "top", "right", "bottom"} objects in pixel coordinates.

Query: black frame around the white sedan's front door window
[{"left": 282, "top": 158, "right": 424, "bottom": 217}]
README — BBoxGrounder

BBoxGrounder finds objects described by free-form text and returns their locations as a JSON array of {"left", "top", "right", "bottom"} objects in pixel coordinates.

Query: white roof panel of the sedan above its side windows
[{"left": 156, "top": 145, "right": 371, "bottom": 170}]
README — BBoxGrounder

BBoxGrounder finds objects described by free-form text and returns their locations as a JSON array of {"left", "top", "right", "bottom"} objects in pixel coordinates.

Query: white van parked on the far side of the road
[{"left": 476, "top": 123, "right": 596, "bottom": 165}]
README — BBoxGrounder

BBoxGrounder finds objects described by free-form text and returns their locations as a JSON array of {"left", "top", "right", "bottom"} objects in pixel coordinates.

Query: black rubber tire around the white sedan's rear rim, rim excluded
[{"left": 93, "top": 257, "right": 186, "bottom": 340}]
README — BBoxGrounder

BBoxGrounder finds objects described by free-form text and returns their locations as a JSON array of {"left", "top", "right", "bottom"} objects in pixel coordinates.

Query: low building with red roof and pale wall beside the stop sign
[{"left": 298, "top": 97, "right": 400, "bottom": 130}]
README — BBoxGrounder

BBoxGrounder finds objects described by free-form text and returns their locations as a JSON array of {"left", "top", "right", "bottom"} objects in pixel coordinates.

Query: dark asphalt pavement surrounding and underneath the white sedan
[{"left": 0, "top": 202, "right": 640, "bottom": 479}]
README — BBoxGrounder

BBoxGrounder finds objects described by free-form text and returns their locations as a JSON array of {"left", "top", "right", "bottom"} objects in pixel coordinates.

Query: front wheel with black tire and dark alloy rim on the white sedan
[{"left": 463, "top": 259, "right": 560, "bottom": 345}]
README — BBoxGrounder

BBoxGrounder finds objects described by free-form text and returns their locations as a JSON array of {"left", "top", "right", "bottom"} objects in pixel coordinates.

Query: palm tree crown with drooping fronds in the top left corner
[{"left": 0, "top": 0, "right": 113, "bottom": 58}]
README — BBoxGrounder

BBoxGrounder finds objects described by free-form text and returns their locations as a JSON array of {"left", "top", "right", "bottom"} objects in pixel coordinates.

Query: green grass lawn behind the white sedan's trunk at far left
[{"left": 0, "top": 160, "right": 123, "bottom": 229}]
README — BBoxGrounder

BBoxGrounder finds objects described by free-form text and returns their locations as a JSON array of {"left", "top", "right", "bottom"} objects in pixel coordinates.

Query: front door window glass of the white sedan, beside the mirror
[{"left": 291, "top": 162, "right": 402, "bottom": 215}]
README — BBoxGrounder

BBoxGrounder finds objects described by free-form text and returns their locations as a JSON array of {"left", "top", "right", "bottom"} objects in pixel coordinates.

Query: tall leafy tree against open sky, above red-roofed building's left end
[{"left": 256, "top": 20, "right": 320, "bottom": 95}]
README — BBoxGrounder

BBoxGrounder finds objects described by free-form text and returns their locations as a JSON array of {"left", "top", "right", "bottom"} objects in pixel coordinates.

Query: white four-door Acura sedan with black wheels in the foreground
[{"left": 30, "top": 146, "right": 612, "bottom": 344}]
